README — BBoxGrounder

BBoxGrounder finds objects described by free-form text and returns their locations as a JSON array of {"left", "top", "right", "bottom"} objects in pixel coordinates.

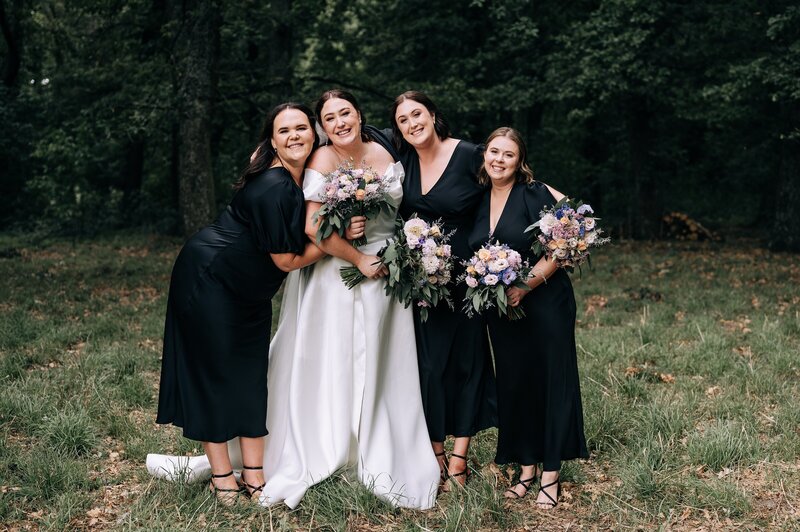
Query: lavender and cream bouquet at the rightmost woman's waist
[{"left": 458, "top": 242, "right": 531, "bottom": 320}]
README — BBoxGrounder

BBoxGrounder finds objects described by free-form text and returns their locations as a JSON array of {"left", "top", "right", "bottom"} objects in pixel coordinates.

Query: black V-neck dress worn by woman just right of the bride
[{"left": 400, "top": 140, "right": 497, "bottom": 441}]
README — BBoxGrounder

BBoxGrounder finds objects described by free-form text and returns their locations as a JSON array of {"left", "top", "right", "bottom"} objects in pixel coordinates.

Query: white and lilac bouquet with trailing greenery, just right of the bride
[{"left": 340, "top": 214, "right": 453, "bottom": 322}]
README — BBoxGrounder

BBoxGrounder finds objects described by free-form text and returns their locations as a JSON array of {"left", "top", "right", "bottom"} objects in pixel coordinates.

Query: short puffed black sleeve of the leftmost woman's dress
[{"left": 248, "top": 180, "right": 306, "bottom": 253}]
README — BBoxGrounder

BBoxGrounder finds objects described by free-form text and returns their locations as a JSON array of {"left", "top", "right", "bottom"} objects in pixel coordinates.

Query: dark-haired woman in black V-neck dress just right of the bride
[{"left": 392, "top": 91, "right": 497, "bottom": 489}]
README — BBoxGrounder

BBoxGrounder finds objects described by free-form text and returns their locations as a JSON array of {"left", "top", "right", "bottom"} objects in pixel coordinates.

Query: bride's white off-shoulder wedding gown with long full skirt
[{"left": 147, "top": 163, "right": 439, "bottom": 509}]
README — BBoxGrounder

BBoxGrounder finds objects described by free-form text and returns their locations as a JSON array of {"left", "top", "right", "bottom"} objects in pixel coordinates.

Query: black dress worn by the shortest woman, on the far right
[{"left": 469, "top": 182, "right": 589, "bottom": 470}]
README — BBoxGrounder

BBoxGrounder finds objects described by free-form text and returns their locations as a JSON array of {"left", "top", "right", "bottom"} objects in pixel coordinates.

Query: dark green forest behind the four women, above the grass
[{"left": 0, "top": 0, "right": 800, "bottom": 245}]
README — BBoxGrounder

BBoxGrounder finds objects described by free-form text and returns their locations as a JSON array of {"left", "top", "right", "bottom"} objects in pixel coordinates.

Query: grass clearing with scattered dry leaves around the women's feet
[{"left": 0, "top": 235, "right": 800, "bottom": 530}]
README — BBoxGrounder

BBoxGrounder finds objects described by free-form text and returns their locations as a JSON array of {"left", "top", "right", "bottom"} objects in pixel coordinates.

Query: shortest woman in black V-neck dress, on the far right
[{"left": 469, "top": 127, "right": 589, "bottom": 509}]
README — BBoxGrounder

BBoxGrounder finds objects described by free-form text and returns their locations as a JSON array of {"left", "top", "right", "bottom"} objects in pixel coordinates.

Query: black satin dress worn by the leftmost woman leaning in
[{"left": 156, "top": 168, "right": 306, "bottom": 442}]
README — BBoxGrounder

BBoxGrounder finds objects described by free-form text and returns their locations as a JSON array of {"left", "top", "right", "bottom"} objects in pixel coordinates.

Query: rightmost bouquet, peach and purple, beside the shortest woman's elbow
[{"left": 525, "top": 197, "right": 611, "bottom": 271}]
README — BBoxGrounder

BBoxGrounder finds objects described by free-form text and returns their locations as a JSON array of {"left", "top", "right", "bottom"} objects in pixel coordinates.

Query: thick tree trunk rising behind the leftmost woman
[{"left": 178, "top": 0, "right": 219, "bottom": 236}]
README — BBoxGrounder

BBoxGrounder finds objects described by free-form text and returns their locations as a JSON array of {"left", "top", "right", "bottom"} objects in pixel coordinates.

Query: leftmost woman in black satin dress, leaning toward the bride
[{"left": 156, "top": 103, "right": 323, "bottom": 504}]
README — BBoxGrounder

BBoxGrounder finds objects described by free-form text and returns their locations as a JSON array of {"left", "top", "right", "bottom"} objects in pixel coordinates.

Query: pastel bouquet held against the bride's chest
[{"left": 313, "top": 161, "right": 394, "bottom": 247}]
